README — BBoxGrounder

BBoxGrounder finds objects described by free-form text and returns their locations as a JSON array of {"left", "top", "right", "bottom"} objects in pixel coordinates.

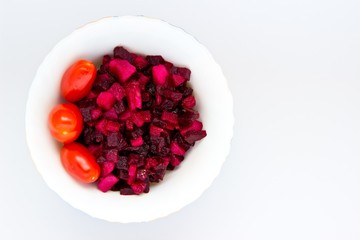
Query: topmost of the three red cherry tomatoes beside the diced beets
[{"left": 61, "top": 60, "right": 96, "bottom": 102}]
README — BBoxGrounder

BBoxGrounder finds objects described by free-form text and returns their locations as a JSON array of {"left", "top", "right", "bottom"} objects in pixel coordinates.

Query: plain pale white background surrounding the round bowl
[{"left": 0, "top": 0, "right": 360, "bottom": 240}]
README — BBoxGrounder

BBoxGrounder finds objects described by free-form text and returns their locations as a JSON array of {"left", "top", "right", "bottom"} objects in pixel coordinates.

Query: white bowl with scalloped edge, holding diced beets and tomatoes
[{"left": 26, "top": 16, "right": 234, "bottom": 223}]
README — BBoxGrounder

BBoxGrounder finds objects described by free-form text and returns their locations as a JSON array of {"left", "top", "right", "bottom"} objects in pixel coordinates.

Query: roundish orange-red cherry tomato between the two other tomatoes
[{"left": 48, "top": 103, "right": 83, "bottom": 143}]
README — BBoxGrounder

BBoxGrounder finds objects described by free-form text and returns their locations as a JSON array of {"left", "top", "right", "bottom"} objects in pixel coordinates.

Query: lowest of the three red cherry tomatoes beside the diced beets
[{"left": 60, "top": 142, "right": 100, "bottom": 183}]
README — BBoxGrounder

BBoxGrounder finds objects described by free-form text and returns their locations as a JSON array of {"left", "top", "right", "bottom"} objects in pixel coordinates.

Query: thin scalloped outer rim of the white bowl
[{"left": 25, "top": 15, "right": 235, "bottom": 223}]
